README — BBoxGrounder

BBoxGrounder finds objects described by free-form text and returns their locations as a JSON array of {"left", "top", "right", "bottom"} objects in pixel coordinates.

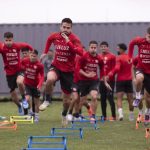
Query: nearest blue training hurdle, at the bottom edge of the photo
[{"left": 22, "top": 136, "right": 67, "bottom": 150}]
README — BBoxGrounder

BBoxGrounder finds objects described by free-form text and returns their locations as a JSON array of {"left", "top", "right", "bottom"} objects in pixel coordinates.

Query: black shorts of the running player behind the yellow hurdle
[{"left": 25, "top": 85, "right": 40, "bottom": 98}]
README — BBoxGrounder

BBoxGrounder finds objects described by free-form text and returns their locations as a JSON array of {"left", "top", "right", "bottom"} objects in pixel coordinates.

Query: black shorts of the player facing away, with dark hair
[{"left": 116, "top": 80, "right": 133, "bottom": 93}]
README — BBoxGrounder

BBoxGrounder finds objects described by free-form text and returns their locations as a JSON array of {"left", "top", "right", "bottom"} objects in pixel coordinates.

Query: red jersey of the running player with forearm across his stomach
[{"left": 79, "top": 52, "right": 103, "bottom": 80}]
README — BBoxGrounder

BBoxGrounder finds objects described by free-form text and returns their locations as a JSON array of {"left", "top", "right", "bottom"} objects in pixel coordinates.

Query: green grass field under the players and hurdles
[{"left": 0, "top": 101, "right": 150, "bottom": 150}]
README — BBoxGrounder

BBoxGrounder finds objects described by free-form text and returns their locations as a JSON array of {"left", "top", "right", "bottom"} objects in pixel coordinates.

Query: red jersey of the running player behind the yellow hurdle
[{"left": 21, "top": 58, "right": 44, "bottom": 88}]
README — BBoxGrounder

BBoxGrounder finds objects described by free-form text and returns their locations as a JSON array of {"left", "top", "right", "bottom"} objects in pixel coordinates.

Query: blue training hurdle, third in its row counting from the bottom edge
[{"left": 71, "top": 120, "right": 98, "bottom": 130}]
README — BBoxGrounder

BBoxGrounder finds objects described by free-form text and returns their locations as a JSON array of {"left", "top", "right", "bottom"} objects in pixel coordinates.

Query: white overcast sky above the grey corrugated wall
[{"left": 0, "top": 0, "right": 150, "bottom": 24}]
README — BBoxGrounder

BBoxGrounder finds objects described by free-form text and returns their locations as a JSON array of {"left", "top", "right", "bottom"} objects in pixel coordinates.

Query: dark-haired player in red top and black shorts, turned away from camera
[{"left": 108, "top": 43, "right": 134, "bottom": 121}]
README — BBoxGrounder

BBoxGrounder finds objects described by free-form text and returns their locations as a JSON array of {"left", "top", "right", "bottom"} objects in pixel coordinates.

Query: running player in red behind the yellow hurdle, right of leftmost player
[{"left": 21, "top": 50, "right": 44, "bottom": 122}]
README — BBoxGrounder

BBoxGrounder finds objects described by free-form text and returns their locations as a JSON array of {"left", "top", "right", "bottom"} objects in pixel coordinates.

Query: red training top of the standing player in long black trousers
[{"left": 100, "top": 52, "right": 116, "bottom": 81}]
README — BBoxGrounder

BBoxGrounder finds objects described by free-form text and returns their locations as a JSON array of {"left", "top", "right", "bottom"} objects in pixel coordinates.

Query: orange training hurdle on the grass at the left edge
[{"left": 0, "top": 120, "right": 17, "bottom": 130}]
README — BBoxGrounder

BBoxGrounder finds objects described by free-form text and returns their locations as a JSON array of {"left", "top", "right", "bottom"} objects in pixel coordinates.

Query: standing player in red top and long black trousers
[{"left": 99, "top": 41, "right": 116, "bottom": 121}]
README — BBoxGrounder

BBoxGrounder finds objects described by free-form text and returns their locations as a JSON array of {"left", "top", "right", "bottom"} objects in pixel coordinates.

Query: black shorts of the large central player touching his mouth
[{"left": 50, "top": 65, "right": 73, "bottom": 94}]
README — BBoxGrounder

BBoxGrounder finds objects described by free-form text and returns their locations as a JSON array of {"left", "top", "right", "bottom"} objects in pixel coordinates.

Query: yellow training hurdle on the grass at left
[{"left": 10, "top": 116, "right": 34, "bottom": 124}]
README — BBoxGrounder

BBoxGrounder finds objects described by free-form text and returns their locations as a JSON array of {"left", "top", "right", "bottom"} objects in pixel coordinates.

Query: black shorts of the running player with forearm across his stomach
[{"left": 79, "top": 80, "right": 99, "bottom": 97}]
